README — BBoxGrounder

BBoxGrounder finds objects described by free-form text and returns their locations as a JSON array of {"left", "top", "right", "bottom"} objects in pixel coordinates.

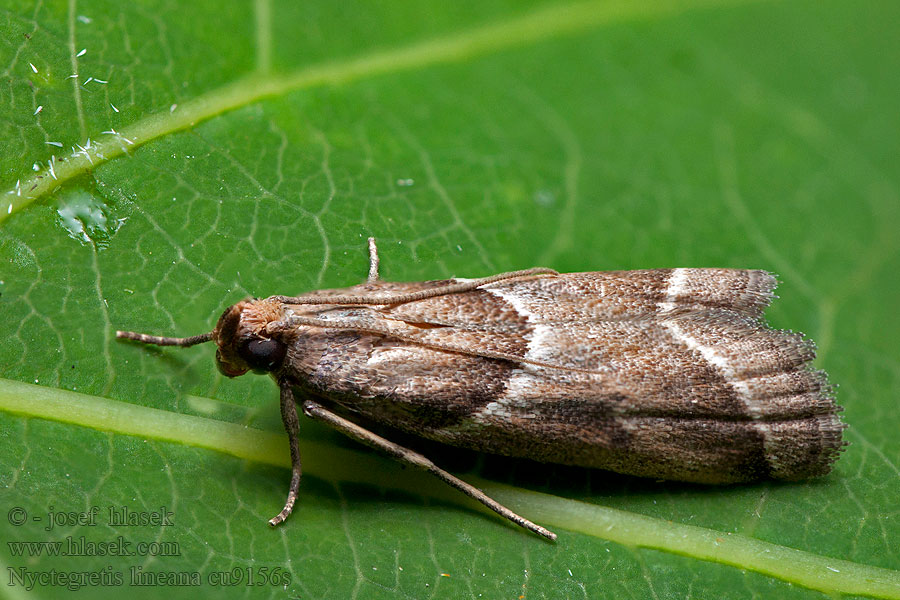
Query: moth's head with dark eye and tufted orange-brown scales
[{"left": 212, "top": 300, "right": 287, "bottom": 377}]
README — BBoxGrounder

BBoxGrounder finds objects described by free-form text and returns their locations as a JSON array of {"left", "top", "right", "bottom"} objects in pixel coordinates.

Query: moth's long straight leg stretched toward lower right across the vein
[{"left": 303, "top": 400, "right": 556, "bottom": 540}]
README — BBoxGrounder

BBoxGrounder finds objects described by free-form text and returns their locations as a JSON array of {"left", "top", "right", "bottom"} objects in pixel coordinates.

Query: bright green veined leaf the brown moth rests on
[{"left": 0, "top": 0, "right": 900, "bottom": 599}]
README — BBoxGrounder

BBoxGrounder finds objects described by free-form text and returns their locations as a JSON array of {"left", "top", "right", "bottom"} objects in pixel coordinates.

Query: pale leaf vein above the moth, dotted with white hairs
[{"left": 0, "top": 0, "right": 754, "bottom": 223}]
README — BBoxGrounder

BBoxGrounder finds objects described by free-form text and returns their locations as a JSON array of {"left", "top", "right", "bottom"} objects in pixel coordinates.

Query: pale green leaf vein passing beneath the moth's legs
[{"left": 0, "top": 379, "right": 900, "bottom": 599}]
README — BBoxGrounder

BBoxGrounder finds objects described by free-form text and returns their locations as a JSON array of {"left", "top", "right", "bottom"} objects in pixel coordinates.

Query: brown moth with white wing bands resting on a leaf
[{"left": 116, "top": 238, "right": 845, "bottom": 540}]
